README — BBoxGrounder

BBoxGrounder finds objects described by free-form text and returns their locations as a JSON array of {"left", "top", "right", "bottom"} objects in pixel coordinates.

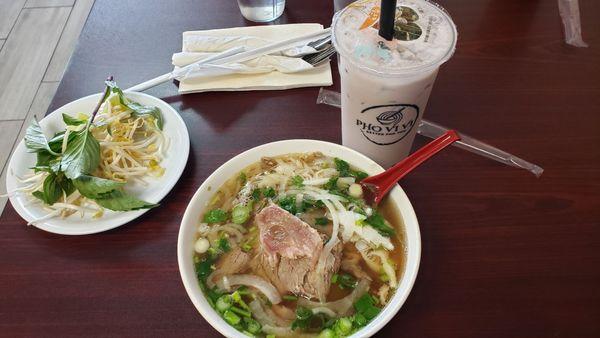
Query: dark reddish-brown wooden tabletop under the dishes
[{"left": 0, "top": 0, "right": 600, "bottom": 338}]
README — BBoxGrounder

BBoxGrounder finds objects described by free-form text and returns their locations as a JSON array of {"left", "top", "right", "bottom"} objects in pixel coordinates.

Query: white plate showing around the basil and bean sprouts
[{"left": 6, "top": 92, "right": 190, "bottom": 235}]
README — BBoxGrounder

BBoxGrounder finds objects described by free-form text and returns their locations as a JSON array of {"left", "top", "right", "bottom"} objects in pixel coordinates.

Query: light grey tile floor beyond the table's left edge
[{"left": 0, "top": 0, "right": 94, "bottom": 214}]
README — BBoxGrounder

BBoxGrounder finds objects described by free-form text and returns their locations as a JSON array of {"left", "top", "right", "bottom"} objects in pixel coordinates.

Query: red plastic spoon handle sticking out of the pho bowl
[{"left": 360, "top": 130, "right": 460, "bottom": 204}]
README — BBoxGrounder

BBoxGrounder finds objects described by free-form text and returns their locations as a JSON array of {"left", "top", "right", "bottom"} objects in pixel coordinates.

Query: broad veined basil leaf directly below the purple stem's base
[{"left": 60, "top": 126, "right": 100, "bottom": 179}]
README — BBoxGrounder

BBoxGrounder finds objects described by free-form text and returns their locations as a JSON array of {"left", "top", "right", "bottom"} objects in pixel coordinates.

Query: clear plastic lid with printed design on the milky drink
[{"left": 332, "top": 0, "right": 458, "bottom": 75}]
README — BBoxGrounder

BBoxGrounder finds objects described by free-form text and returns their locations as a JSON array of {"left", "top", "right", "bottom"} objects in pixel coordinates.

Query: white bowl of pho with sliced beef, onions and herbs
[{"left": 177, "top": 140, "right": 421, "bottom": 338}]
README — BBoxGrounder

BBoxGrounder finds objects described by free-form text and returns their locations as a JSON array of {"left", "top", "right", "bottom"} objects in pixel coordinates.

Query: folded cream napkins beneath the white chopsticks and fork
[{"left": 172, "top": 24, "right": 332, "bottom": 94}]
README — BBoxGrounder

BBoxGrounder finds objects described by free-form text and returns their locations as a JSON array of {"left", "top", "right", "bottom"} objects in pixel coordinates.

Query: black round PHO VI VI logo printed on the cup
[{"left": 356, "top": 104, "right": 419, "bottom": 145}]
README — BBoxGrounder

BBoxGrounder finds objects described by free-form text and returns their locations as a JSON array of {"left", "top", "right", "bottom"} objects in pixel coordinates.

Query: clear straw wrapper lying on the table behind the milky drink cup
[{"left": 317, "top": 88, "right": 544, "bottom": 177}]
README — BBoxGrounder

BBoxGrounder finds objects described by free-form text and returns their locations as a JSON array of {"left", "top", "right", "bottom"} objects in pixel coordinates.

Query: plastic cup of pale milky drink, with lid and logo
[{"left": 332, "top": 0, "right": 457, "bottom": 167}]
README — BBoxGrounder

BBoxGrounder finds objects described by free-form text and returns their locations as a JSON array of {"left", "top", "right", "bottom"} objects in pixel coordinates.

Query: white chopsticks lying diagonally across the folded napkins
[{"left": 126, "top": 28, "right": 331, "bottom": 91}]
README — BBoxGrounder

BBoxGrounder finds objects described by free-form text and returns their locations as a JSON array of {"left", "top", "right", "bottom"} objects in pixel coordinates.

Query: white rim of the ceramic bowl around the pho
[{"left": 177, "top": 140, "right": 421, "bottom": 337}]
